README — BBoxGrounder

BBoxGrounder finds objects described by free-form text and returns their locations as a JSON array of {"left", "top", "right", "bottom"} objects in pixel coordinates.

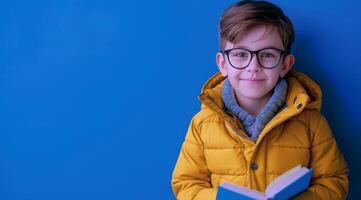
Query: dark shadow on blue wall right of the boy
[{"left": 293, "top": 35, "right": 361, "bottom": 199}]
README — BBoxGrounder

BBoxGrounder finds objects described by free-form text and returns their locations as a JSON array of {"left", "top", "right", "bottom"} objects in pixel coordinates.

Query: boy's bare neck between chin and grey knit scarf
[{"left": 235, "top": 92, "right": 272, "bottom": 117}]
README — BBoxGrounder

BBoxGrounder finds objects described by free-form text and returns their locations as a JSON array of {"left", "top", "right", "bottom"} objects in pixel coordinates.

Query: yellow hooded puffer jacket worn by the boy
[{"left": 172, "top": 71, "right": 349, "bottom": 200}]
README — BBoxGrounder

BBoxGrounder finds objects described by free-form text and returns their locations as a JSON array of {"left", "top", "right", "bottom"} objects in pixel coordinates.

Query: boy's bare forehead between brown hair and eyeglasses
[{"left": 226, "top": 25, "right": 283, "bottom": 51}]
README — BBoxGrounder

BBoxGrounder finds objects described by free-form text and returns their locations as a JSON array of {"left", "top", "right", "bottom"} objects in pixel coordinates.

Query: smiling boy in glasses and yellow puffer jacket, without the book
[{"left": 172, "top": 0, "right": 348, "bottom": 200}]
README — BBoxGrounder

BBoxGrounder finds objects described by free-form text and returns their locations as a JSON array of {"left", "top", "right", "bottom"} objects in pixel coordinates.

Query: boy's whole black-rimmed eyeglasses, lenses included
[{"left": 220, "top": 48, "right": 288, "bottom": 69}]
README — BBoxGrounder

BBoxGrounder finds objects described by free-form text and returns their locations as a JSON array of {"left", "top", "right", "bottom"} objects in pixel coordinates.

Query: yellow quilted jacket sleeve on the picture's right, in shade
[{"left": 294, "top": 115, "right": 349, "bottom": 200}]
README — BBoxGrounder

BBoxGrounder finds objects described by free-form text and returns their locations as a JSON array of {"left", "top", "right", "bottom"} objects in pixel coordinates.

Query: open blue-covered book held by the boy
[{"left": 217, "top": 165, "right": 313, "bottom": 200}]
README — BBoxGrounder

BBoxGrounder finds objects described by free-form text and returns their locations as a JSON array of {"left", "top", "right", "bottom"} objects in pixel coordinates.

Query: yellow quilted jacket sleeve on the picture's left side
[{"left": 172, "top": 118, "right": 216, "bottom": 200}]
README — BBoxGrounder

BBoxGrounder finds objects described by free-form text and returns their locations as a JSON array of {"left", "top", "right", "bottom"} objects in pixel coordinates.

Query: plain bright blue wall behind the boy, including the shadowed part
[{"left": 0, "top": 0, "right": 361, "bottom": 200}]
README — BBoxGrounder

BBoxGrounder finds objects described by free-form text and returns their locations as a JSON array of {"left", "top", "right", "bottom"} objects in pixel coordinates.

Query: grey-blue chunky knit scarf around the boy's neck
[{"left": 222, "top": 79, "right": 287, "bottom": 141}]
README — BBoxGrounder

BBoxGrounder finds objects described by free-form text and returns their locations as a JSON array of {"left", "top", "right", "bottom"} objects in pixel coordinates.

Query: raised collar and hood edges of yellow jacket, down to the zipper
[{"left": 199, "top": 71, "right": 322, "bottom": 144}]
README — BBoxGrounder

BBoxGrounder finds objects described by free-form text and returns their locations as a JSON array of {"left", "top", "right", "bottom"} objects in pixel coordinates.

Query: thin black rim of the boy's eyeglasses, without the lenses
[{"left": 219, "top": 47, "right": 289, "bottom": 69}]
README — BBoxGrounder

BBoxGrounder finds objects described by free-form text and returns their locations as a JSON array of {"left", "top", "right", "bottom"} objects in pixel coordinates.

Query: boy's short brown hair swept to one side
[{"left": 219, "top": 0, "right": 295, "bottom": 52}]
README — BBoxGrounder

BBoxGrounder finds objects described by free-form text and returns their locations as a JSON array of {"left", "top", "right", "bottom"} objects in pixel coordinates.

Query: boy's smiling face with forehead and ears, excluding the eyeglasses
[{"left": 216, "top": 25, "right": 294, "bottom": 100}]
